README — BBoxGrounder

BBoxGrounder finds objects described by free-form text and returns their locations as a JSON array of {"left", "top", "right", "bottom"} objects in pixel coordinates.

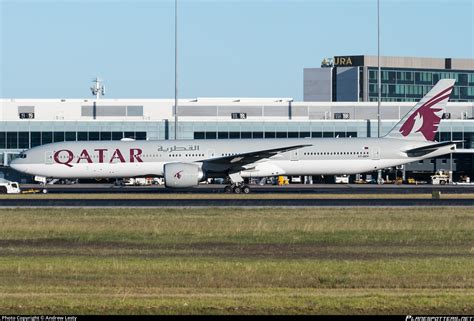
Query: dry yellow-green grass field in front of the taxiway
[{"left": 0, "top": 208, "right": 474, "bottom": 315}]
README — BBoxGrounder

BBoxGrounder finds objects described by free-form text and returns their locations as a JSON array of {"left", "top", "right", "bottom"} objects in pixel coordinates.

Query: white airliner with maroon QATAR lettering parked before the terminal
[{"left": 11, "top": 79, "right": 456, "bottom": 193}]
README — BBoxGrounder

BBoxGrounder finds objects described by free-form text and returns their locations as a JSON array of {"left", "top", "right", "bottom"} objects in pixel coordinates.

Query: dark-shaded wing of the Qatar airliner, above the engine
[{"left": 202, "top": 144, "right": 312, "bottom": 171}]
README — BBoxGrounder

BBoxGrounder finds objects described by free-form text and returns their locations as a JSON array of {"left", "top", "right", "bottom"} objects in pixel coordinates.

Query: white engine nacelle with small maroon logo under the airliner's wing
[{"left": 164, "top": 163, "right": 204, "bottom": 188}]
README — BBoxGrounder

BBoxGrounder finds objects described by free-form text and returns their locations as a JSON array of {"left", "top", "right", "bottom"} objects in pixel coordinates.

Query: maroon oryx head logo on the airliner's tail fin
[{"left": 400, "top": 86, "right": 453, "bottom": 141}]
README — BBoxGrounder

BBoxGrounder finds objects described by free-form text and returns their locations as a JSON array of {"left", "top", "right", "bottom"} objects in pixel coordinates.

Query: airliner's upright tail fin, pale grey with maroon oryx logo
[{"left": 385, "top": 79, "right": 456, "bottom": 141}]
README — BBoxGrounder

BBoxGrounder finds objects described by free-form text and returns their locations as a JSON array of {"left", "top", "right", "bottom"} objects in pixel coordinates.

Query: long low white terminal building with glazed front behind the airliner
[{"left": 0, "top": 94, "right": 474, "bottom": 182}]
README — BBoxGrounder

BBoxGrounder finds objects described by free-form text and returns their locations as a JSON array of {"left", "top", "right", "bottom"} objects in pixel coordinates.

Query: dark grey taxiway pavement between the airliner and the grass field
[{"left": 4, "top": 184, "right": 474, "bottom": 208}]
